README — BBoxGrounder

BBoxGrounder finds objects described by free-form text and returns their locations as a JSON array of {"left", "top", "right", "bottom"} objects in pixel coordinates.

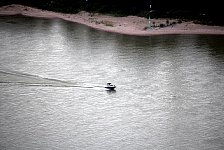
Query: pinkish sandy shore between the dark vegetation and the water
[{"left": 0, "top": 5, "right": 224, "bottom": 36}]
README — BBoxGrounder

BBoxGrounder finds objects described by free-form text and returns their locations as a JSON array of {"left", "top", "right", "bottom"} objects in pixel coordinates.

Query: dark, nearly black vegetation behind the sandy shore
[{"left": 0, "top": 0, "right": 224, "bottom": 26}]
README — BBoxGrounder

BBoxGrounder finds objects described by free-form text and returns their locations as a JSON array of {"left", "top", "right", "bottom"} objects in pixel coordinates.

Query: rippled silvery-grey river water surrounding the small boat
[{"left": 0, "top": 16, "right": 224, "bottom": 150}]
